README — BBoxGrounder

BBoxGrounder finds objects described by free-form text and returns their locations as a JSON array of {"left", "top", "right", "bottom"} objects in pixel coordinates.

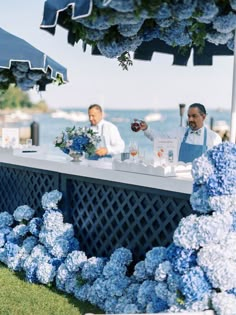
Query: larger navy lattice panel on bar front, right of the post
[{"left": 67, "top": 180, "right": 192, "bottom": 259}]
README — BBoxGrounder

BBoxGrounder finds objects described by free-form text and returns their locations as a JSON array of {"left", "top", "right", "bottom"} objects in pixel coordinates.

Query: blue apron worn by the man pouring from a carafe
[{"left": 179, "top": 127, "right": 207, "bottom": 163}]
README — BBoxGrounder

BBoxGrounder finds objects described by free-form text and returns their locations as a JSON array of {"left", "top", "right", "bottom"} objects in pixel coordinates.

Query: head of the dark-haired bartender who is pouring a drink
[{"left": 188, "top": 103, "right": 207, "bottom": 130}]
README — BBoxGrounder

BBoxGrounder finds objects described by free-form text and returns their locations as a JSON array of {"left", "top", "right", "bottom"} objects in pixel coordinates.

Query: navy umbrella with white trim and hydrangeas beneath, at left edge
[{"left": 0, "top": 28, "right": 67, "bottom": 91}]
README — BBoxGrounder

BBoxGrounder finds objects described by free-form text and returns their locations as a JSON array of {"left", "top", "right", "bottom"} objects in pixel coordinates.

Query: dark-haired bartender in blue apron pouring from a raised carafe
[{"left": 134, "top": 103, "right": 222, "bottom": 163}]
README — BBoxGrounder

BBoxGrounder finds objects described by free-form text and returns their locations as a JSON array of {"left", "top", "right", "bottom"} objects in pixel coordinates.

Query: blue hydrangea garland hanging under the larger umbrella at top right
[{"left": 42, "top": 0, "right": 236, "bottom": 58}]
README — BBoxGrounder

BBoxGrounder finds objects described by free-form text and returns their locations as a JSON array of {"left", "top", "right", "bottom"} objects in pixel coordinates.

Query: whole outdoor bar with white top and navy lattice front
[{"left": 0, "top": 148, "right": 192, "bottom": 260}]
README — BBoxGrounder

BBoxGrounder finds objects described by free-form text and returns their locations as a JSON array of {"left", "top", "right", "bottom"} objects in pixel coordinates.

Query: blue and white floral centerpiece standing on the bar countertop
[{"left": 54, "top": 126, "right": 101, "bottom": 158}]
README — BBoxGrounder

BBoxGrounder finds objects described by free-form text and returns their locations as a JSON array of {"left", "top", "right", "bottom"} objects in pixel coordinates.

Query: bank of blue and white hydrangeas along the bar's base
[{"left": 0, "top": 142, "right": 236, "bottom": 315}]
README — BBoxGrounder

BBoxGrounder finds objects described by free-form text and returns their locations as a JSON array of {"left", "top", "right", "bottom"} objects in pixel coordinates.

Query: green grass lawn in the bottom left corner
[{"left": 0, "top": 265, "right": 103, "bottom": 315}]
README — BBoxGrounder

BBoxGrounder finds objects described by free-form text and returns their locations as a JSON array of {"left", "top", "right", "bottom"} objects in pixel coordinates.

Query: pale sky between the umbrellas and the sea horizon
[{"left": 0, "top": 0, "right": 233, "bottom": 110}]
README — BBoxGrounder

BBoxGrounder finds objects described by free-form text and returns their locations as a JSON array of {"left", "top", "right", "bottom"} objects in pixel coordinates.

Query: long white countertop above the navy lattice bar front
[{"left": 0, "top": 147, "right": 193, "bottom": 194}]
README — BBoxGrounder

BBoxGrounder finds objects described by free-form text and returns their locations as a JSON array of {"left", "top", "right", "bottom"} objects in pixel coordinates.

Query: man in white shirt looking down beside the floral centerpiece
[{"left": 88, "top": 104, "right": 125, "bottom": 157}]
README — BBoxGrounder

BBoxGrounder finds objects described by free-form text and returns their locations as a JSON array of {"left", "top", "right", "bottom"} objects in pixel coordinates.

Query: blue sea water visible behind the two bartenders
[{"left": 30, "top": 108, "right": 230, "bottom": 155}]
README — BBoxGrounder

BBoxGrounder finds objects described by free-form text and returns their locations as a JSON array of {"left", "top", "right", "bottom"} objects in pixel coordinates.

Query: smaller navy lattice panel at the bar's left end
[{"left": 0, "top": 165, "right": 59, "bottom": 215}]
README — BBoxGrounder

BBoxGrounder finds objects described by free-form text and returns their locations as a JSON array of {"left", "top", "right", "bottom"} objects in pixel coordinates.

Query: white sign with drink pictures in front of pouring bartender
[{"left": 154, "top": 138, "right": 178, "bottom": 166}]
